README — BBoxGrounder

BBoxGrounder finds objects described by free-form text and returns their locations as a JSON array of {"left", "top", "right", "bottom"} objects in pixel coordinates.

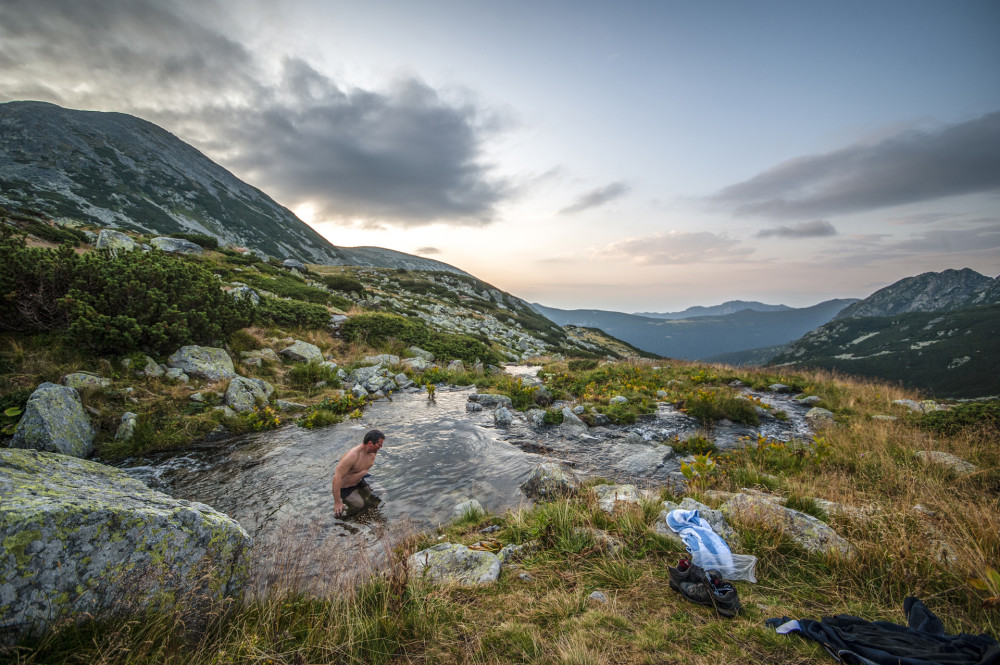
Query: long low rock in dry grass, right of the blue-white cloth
[{"left": 720, "top": 493, "right": 852, "bottom": 556}]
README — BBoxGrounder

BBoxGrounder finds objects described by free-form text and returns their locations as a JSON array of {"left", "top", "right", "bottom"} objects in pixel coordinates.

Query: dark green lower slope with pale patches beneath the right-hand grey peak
[{"left": 771, "top": 304, "right": 1000, "bottom": 397}]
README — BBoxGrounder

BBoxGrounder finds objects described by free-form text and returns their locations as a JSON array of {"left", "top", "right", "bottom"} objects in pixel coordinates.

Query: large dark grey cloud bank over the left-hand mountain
[{"left": 0, "top": 0, "right": 515, "bottom": 227}]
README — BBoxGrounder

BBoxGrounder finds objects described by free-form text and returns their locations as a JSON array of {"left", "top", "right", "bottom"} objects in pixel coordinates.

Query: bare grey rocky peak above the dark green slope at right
[{"left": 836, "top": 268, "right": 1000, "bottom": 319}]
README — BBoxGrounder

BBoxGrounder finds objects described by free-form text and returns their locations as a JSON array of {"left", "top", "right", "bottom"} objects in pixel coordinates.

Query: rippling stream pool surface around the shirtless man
[{"left": 126, "top": 389, "right": 538, "bottom": 546}]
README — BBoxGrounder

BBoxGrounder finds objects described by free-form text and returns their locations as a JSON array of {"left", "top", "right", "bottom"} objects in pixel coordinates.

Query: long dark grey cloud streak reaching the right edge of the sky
[{"left": 710, "top": 112, "right": 1000, "bottom": 219}]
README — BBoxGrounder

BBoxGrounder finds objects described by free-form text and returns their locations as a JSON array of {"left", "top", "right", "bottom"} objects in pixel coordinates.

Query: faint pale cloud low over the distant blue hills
[{"left": 595, "top": 231, "right": 754, "bottom": 266}]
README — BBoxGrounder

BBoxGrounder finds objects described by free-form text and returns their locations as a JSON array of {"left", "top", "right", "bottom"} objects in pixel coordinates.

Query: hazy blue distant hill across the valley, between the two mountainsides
[{"left": 532, "top": 299, "right": 854, "bottom": 360}]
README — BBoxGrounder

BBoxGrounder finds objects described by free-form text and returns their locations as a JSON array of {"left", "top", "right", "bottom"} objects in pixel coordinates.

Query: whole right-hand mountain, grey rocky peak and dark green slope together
[{"left": 770, "top": 268, "right": 1000, "bottom": 397}]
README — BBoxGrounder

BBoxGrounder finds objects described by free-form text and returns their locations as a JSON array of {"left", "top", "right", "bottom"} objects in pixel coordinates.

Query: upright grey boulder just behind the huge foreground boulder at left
[{"left": 10, "top": 383, "right": 96, "bottom": 457}]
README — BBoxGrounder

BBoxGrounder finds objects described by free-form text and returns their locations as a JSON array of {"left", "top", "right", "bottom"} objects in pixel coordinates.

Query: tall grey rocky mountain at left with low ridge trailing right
[{"left": 0, "top": 102, "right": 467, "bottom": 274}]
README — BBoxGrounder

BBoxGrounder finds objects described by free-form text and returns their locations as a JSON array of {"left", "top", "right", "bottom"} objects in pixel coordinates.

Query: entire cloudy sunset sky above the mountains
[{"left": 0, "top": 0, "right": 1000, "bottom": 312}]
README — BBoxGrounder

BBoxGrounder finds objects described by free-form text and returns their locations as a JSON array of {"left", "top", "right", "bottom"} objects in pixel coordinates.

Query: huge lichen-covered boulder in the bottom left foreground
[{"left": 0, "top": 450, "right": 253, "bottom": 639}]
